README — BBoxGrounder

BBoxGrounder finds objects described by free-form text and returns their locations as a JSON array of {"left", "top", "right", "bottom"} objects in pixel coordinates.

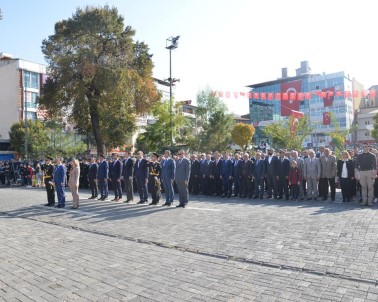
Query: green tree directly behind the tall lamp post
[{"left": 136, "top": 102, "right": 185, "bottom": 152}]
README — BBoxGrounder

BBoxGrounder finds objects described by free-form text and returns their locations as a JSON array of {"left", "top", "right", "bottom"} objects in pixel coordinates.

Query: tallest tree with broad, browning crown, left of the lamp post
[{"left": 39, "top": 6, "right": 160, "bottom": 154}]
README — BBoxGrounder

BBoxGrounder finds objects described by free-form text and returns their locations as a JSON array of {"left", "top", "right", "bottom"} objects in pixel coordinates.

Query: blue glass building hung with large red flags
[{"left": 249, "top": 61, "right": 354, "bottom": 148}]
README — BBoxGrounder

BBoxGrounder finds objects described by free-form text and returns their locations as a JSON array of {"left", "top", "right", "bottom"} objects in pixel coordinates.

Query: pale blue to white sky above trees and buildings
[{"left": 0, "top": 0, "right": 378, "bottom": 114}]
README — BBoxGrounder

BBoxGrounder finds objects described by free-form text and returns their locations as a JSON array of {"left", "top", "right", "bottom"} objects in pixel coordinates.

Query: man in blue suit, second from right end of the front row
[{"left": 161, "top": 150, "right": 176, "bottom": 206}]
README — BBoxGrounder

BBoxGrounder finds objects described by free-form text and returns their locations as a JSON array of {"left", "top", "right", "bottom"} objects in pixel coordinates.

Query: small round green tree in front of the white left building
[{"left": 9, "top": 120, "right": 49, "bottom": 158}]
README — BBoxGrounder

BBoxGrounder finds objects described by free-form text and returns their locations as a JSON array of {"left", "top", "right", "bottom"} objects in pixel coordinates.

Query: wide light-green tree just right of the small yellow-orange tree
[{"left": 263, "top": 116, "right": 312, "bottom": 150}]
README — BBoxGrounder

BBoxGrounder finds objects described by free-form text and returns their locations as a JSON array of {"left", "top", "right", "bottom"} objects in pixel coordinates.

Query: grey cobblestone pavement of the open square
[{"left": 0, "top": 187, "right": 378, "bottom": 301}]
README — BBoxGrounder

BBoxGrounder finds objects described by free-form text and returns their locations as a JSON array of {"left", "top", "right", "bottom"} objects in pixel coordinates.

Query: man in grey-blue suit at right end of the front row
[{"left": 175, "top": 150, "right": 190, "bottom": 208}]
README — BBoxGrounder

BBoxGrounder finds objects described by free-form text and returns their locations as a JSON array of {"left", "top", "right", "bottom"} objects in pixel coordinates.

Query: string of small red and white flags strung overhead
[{"left": 211, "top": 87, "right": 376, "bottom": 101}]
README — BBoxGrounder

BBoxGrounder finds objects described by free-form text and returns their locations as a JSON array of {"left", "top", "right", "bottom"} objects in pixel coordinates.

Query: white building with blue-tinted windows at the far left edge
[{"left": 0, "top": 53, "right": 47, "bottom": 141}]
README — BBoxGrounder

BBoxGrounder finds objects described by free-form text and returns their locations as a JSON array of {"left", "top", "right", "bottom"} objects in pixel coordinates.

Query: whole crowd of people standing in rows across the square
[{"left": 0, "top": 144, "right": 378, "bottom": 209}]
